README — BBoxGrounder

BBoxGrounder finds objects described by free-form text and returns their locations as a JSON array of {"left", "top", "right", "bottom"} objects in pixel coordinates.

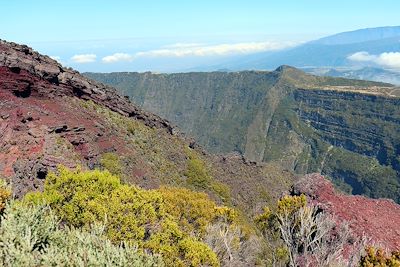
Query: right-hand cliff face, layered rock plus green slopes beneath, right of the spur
[{"left": 264, "top": 89, "right": 400, "bottom": 201}]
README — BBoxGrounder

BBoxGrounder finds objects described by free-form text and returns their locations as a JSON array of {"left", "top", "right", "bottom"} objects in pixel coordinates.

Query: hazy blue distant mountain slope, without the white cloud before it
[{"left": 214, "top": 26, "right": 400, "bottom": 84}]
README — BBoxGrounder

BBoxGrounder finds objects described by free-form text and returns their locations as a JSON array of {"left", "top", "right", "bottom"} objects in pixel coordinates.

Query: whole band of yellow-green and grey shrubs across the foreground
[{"left": 0, "top": 171, "right": 399, "bottom": 267}]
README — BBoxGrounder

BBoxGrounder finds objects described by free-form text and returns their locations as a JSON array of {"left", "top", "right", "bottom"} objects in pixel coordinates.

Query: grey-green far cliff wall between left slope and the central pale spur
[{"left": 87, "top": 72, "right": 277, "bottom": 157}]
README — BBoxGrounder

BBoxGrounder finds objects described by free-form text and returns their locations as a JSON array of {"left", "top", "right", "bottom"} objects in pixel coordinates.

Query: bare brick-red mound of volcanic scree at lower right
[{"left": 295, "top": 174, "right": 400, "bottom": 250}]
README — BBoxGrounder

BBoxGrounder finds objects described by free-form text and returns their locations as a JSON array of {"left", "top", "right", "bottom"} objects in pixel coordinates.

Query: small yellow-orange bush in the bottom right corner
[{"left": 359, "top": 247, "right": 400, "bottom": 267}]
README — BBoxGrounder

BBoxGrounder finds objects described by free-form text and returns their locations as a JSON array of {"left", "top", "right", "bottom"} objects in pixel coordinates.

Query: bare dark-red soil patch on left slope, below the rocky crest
[{"left": 0, "top": 67, "right": 125, "bottom": 195}]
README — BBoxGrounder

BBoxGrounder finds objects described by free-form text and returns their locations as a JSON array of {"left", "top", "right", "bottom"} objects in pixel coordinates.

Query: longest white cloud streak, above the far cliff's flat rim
[{"left": 102, "top": 42, "right": 295, "bottom": 63}]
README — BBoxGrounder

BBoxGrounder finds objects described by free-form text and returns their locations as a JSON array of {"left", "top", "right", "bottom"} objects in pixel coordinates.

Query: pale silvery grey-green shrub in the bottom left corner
[{"left": 0, "top": 201, "right": 163, "bottom": 267}]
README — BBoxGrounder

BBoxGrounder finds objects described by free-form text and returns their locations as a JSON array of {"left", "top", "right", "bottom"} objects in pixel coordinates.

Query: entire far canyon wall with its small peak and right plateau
[{"left": 86, "top": 66, "right": 400, "bottom": 201}]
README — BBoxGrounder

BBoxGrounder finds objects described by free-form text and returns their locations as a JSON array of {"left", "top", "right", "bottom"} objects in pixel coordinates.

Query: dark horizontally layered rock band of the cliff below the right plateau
[{"left": 294, "top": 89, "right": 400, "bottom": 165}]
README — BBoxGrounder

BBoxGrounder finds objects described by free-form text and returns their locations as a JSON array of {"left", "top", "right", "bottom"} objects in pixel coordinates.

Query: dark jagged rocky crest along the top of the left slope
[{"left": 0, "top": 40, "right": 174, "bottom": 132}]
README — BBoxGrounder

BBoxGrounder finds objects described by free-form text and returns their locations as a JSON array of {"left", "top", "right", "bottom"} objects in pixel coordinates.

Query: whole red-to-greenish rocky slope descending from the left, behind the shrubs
[{"left": 0, "top": 41, "right": 293, "bottom": 218}]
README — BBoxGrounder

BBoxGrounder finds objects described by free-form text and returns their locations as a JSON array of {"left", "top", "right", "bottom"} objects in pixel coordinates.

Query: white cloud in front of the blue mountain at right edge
[{"left": 347, "top": 51, "right": 400, "bottom": 69}]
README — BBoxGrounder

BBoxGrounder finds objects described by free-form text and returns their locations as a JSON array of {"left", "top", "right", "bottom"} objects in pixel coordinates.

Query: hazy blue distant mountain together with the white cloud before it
[{"left": 203, "top": 26, "right": 400, "bottom": 84}]
